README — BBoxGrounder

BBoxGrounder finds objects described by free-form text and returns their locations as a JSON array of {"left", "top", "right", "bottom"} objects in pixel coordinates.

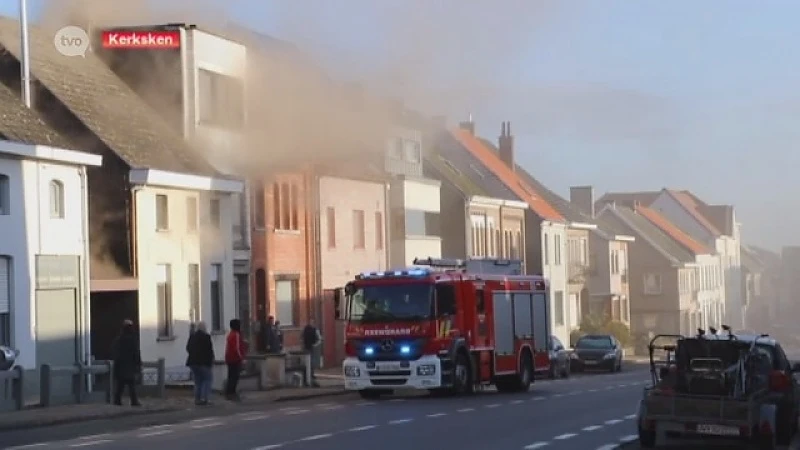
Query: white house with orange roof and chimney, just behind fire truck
[{"left": 451, "top": 119, "right": 578, "bottom": 342}]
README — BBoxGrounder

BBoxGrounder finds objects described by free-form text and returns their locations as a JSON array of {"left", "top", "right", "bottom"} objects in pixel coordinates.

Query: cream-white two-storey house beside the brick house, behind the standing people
[{"left": 129, "top": 169, "right": 243, "bottom": 377}]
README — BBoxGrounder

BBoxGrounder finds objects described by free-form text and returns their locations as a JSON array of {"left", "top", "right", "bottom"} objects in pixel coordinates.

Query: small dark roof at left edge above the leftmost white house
[{"left": 0, "top": 84, "right": 73, "bottom": 149}]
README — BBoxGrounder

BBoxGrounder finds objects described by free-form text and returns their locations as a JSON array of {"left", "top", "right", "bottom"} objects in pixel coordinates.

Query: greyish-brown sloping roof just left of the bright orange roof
[{"left": 425, "top": 131, "right": 520, "bottom": 201}]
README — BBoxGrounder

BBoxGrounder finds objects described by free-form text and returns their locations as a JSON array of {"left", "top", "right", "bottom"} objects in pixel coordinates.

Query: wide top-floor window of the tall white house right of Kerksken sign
[{"left": 197, "top": 69, "right": 244, "bottom": 129}]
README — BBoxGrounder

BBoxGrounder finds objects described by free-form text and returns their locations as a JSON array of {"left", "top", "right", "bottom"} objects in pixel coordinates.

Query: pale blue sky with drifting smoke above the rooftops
[{"left": 0, "top": 0, "right": 800, "bottom": 250}]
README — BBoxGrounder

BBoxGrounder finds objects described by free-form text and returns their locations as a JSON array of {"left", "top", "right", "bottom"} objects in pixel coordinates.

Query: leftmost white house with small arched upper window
[{"left": 0, "top": 140, "right": 102, "bottom": 371}]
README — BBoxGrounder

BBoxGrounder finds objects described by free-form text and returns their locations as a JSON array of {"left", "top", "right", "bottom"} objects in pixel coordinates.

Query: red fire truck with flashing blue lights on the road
[{"left": 334, "top": 258, "right": 550, "bottom": 399}]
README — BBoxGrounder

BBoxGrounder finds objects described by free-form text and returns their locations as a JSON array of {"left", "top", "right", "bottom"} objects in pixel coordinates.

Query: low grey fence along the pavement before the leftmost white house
[{"left": 0, "top": 358, "right": 166, "bottom": 411}]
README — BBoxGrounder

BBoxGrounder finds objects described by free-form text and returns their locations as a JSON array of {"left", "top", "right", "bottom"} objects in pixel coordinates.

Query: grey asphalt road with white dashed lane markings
[{"left": 0, "top": 366, "right": 649, "bottom": 450}]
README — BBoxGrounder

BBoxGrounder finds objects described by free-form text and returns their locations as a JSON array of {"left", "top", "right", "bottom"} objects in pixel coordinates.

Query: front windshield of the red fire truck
[{"left": 350, "top": 283, "right": 433, "bottom": 323}]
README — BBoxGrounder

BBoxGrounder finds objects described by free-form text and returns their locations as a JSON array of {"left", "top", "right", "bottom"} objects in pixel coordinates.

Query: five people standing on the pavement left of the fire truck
[{"left": 112, "top": 316, "right": 322, "bottom": 406}]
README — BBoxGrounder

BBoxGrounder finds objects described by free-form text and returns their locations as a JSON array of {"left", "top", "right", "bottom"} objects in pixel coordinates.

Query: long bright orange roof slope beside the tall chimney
[{"left": 451, "top": 128, "right": 564, "bottom": 222}]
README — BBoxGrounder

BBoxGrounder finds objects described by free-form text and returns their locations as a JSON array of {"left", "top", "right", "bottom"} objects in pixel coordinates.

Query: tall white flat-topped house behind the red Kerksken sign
[{"left": 98, "top": 24, "right": 252, "bottom": 334}]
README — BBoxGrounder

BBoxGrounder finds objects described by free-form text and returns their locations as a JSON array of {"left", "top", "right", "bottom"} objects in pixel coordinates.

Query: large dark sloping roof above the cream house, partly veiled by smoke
[{"left": 0, "top": 17, "right": 219, "bottom": 176}]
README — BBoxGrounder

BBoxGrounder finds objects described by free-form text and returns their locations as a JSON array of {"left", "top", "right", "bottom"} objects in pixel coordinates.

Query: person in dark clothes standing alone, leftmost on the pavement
[{"left": 112, "top": 319, "right": 142, "bottom": 406}]
